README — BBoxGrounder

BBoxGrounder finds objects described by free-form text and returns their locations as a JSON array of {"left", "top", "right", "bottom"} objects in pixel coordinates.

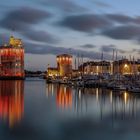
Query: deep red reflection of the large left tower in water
[{"left": 0, "top": 80, "right": 24, "bottom": 127}]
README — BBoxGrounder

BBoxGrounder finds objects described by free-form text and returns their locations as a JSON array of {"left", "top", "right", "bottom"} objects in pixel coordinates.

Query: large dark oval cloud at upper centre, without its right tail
[{"left": 59, "top": 14, "right": 111, "bottom": 32}]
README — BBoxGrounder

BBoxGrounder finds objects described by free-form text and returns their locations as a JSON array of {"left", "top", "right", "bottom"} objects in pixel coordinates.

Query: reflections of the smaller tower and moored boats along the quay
[{"left": 46, "top": 84, "right": 140, "bottom": 120}]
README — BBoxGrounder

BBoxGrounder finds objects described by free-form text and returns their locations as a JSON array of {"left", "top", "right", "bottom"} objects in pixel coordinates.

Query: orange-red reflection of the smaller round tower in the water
[{"left": 56, "top": 85, "right": 72, "bottom": 108}]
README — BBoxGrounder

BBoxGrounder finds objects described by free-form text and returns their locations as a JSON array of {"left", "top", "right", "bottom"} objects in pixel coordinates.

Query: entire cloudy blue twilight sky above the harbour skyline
[{"left": 0, "top": 0, "right": 140, "bottom": 70}]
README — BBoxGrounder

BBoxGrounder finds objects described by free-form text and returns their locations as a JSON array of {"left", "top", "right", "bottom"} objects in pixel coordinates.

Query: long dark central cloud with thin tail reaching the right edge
[{"left": 59, "top": 14, "right": 136, "bottom": 32}]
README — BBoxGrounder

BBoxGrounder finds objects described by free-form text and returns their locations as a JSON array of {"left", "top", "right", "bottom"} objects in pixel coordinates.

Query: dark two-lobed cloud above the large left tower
[{"left": 0, "top": 7, "right": 58, "bottom": 43}]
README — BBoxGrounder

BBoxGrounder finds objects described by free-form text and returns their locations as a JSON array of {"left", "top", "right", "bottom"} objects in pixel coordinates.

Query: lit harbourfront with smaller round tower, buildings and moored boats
[{"left": 46, "top": 54, "right": 140, "bottom": 93}]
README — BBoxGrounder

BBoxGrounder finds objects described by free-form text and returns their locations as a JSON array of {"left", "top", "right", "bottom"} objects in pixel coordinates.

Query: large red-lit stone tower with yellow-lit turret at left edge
[{"left": 0, "top": 36, "right": 24, "bottom": 79}]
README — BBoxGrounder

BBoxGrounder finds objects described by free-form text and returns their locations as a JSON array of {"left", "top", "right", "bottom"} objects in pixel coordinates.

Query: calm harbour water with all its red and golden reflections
[{"left": 0, "top": 79, "right": 140, "bottom": 140}]
